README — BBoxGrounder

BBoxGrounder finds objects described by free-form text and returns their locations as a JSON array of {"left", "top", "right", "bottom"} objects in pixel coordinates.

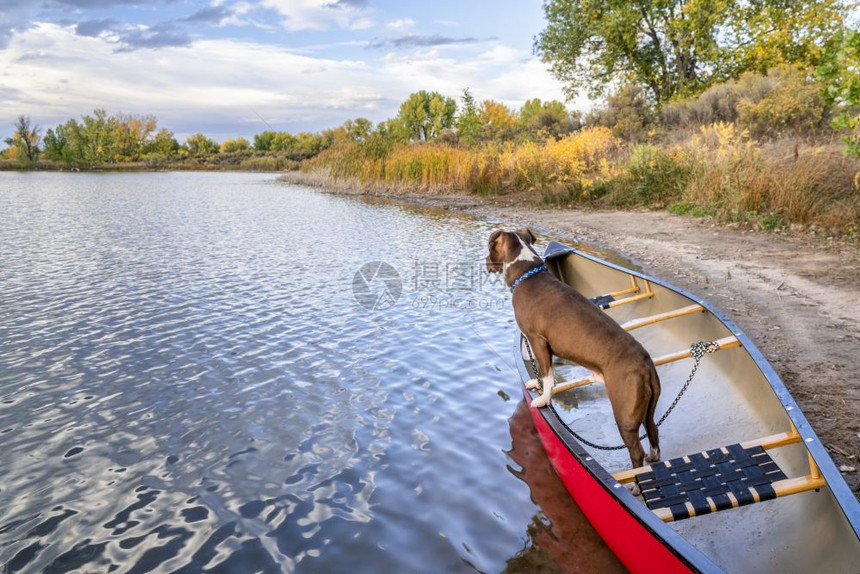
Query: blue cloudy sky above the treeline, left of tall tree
[{"left": 0, "top": 0, "right": 588, "bottom": 142}]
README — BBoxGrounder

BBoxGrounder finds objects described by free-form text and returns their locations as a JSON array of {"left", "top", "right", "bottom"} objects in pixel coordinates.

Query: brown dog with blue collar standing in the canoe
[{"left": 487, "top": 229, "right": 660, "bottom": 468}]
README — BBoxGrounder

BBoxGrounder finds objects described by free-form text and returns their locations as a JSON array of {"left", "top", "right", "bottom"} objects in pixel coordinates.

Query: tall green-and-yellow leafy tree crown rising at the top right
[{"left": 534, "top": 0, "right": 856, "bottom": 106}]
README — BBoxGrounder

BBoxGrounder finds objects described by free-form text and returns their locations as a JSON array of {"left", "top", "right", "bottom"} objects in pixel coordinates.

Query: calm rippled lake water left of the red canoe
[{"left": 0, "top": 173, "right": 618, "bottom": 572}]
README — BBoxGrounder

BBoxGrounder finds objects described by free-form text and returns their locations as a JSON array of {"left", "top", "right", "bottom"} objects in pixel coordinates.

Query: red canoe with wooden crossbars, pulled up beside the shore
[{"left": 515, "top": 242, "right": 860, "bottom": 574}]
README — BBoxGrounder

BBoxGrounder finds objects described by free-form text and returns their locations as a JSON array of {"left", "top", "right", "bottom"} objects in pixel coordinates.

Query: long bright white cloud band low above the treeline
[{"left": 0, "top": 23, "right": 576, "bottom": 139}]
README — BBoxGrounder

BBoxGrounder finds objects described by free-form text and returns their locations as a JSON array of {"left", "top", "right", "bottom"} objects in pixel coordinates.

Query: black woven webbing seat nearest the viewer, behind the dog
[{"left": 636, "top": 444, "right": 785, "bottom": 520}]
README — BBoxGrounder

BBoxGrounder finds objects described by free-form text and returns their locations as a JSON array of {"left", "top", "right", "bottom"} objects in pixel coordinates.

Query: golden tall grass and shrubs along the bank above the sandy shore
[{"left": 301, "top": 123, "right": 860, "bottom": 237}]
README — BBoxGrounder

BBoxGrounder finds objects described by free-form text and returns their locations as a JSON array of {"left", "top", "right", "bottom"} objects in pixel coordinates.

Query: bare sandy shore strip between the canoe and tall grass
[{"left": 279, "top": 174, "right": 860, "bottom": 499}]
